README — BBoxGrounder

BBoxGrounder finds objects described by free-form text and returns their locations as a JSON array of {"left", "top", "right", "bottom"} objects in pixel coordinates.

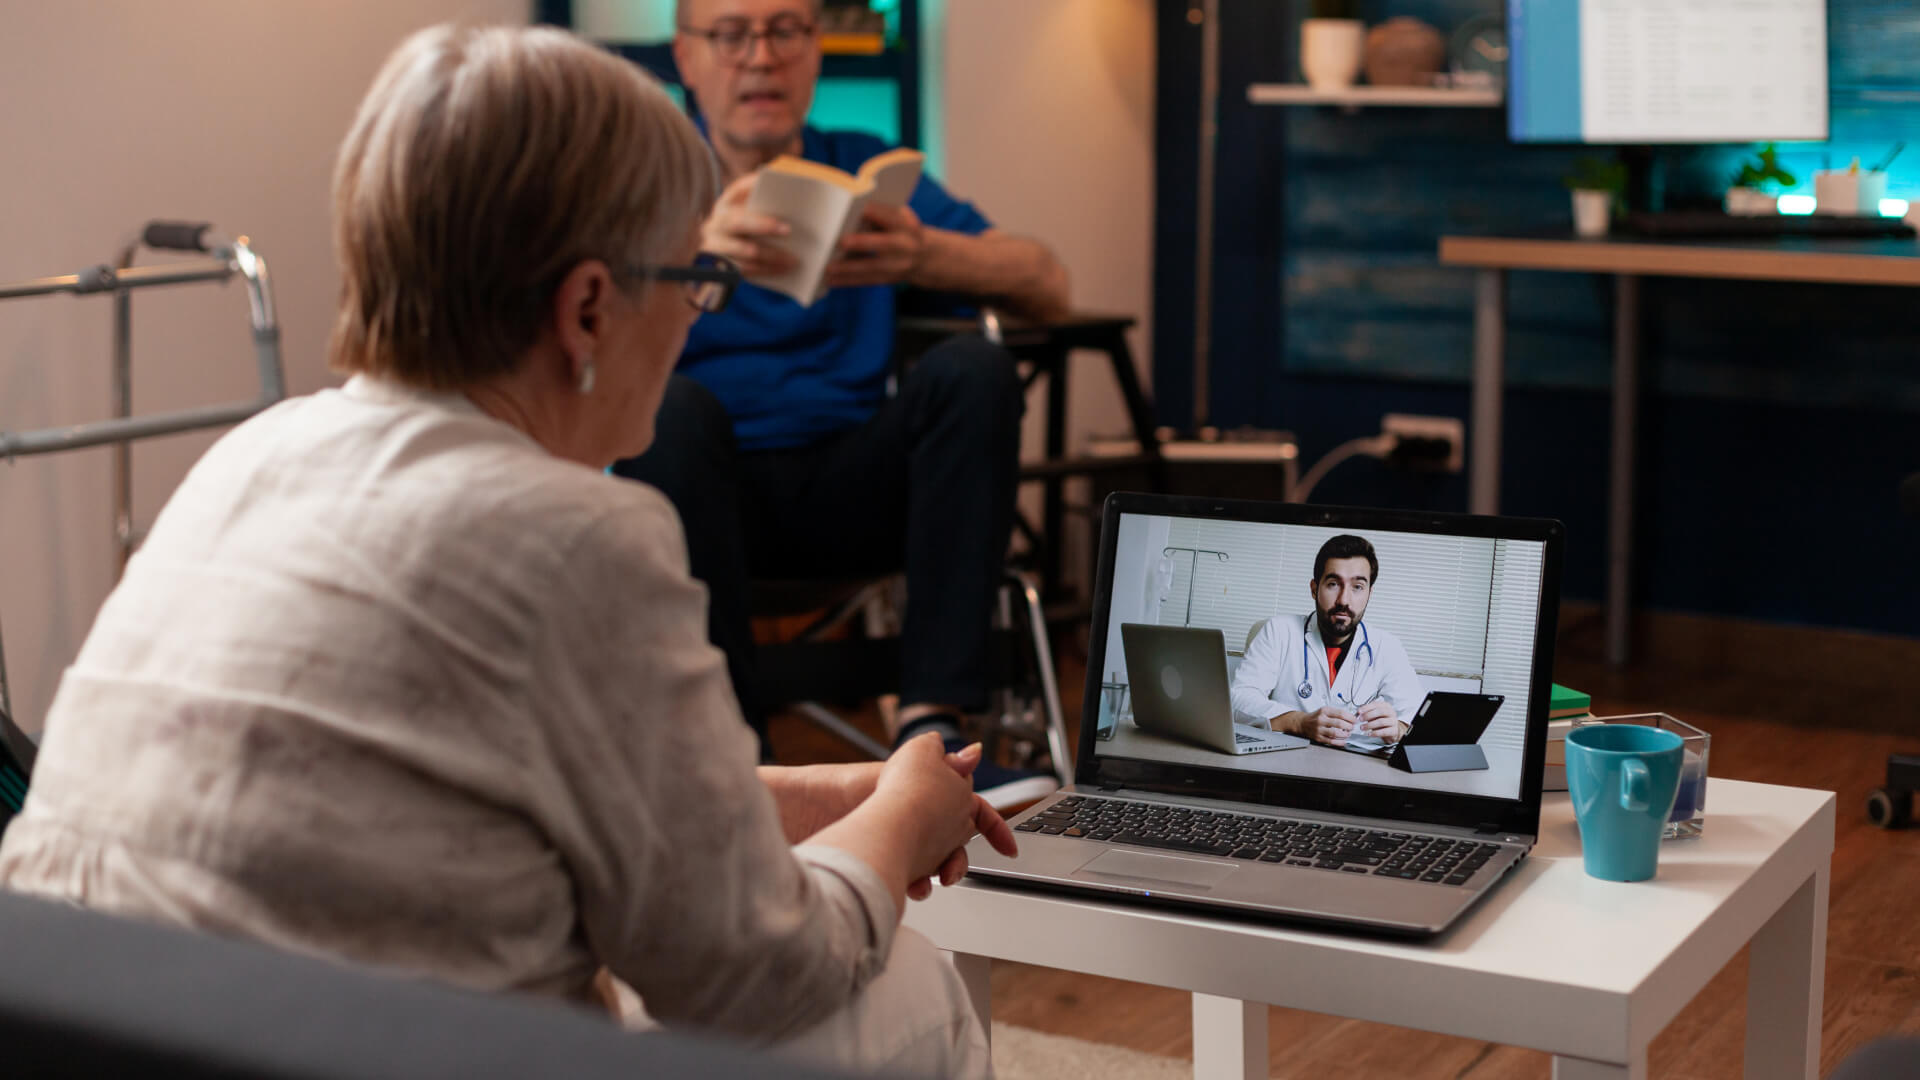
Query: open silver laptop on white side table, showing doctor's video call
[{"left": 968, "top": 494, "right": 1565, "bottom": 938}]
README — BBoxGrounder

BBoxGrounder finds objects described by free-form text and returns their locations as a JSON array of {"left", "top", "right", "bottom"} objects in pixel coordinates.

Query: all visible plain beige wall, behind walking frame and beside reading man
[{"left": 0, "top": 0, "right": 1154, "bottom": 730}]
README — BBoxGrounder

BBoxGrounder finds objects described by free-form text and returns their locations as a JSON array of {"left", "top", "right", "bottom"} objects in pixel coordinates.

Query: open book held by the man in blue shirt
[{"left": 747, "top": 146, "right": 925, "bottom": 307}]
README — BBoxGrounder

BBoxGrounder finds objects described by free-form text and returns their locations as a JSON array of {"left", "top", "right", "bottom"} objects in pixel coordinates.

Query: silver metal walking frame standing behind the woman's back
[{"left": 0, "top": 221, "right": 286, "bottom": 734}]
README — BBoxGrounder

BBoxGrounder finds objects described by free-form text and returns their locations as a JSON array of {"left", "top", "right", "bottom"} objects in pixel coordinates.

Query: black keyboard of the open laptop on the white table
[{"left": 1014, "top": 796, "right": 1500, "bottom": 886}]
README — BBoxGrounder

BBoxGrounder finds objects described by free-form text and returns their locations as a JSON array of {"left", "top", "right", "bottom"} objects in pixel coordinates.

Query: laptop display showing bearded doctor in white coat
[{"left": 1083, "top": 496, "right": 1557, "bottom": 801}]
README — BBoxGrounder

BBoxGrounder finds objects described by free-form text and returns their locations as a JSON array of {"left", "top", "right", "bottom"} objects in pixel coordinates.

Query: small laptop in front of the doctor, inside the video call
[{"left": 1119, "top": 623, "right": 1311, "bottom": 753}]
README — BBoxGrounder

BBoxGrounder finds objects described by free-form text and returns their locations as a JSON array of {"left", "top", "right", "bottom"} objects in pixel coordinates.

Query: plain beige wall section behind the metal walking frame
[{"left": 0, "top": 0, "right": 528, "bottom": 730}]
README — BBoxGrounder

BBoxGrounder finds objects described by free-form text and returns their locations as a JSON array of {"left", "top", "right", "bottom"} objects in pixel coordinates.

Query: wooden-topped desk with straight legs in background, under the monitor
[{"left": 1440, "top": 236, "right": 1920, "bottom": 663}]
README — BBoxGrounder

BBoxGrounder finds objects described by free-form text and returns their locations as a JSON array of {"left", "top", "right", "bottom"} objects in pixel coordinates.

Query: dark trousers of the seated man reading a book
[{"left": 614, "top": 336, "right": 1025, "bottom": 751}]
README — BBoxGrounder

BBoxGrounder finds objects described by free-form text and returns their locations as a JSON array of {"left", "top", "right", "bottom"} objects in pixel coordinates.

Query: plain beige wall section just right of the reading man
[{"left": 927, "top": 0, "right": 1154, "bottom": 588}]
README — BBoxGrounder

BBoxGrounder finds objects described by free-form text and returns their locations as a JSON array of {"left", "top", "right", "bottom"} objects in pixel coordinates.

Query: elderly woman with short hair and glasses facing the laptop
[{"left": 0, "top": 27, "right": 1012, "bottom": 1074}]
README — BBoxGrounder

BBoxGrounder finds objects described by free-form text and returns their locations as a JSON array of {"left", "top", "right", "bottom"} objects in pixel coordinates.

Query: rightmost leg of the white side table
[{"left": 1747, "top": 865, "right": 1828, "bottom": 1080}]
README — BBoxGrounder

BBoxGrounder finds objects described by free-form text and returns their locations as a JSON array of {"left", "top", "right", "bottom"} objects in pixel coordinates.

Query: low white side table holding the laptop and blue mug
[{"left": 906, "top": 780, "right": 1834, "bottom": 1080}]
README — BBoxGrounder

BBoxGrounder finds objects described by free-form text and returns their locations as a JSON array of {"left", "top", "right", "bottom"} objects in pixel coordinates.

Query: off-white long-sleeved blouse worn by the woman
[{"left": 0, "top": 377, "right": 899, "bottom": 1040}]
